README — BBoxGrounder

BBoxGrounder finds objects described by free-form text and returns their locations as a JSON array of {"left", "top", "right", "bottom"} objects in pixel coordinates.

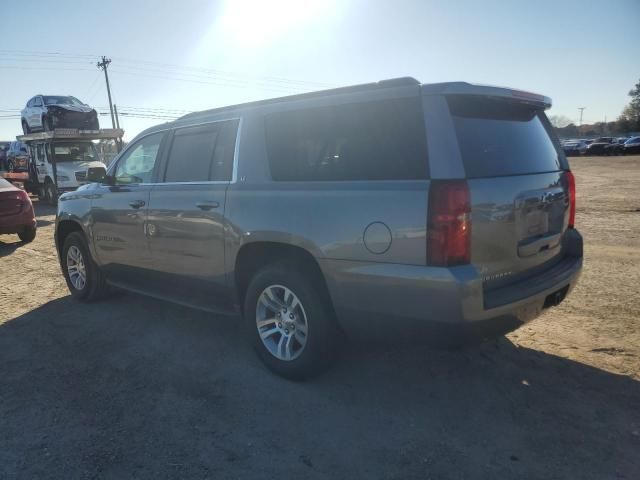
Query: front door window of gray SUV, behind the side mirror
[{"left": 115, "top": 132, "right": 164, "bottom": 185}]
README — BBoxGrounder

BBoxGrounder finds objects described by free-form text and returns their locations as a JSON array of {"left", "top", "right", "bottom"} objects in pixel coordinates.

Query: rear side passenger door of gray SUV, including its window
[{"left": 147, "top": 120, "right": 238, "bottom": 308}]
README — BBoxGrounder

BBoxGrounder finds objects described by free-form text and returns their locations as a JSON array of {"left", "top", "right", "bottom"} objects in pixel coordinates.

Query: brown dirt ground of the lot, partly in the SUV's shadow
[{"left": 0, "top": 156, "right": 640, "bottom": 479}]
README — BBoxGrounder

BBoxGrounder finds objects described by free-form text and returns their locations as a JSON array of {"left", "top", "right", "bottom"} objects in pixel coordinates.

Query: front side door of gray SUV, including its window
[{"left": 91, "top": 132, "right": 164, "bottom": 288}]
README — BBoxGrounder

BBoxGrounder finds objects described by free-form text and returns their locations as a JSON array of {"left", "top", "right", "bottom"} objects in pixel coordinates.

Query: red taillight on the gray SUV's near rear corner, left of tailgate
[{"left": 427, "top": 180, "right": 471, "bottom": 267}]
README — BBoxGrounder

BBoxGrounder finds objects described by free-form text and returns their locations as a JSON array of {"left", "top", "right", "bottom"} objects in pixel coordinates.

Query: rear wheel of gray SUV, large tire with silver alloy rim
[{"left": 244, "top": 264, "right": 341, "bottom": 380}]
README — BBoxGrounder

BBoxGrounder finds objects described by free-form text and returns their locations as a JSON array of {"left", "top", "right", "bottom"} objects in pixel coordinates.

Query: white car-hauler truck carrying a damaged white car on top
[{"left": 16, "top": 128, "right": 124, "bottom": 205}]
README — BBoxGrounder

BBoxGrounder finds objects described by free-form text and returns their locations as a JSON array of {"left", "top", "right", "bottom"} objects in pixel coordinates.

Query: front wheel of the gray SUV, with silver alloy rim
[{"left": 60, "top": 232, "right": 108, "bottom": 302}]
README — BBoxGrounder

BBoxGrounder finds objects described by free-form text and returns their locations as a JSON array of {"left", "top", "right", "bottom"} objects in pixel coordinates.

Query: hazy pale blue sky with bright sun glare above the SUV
[{"left": 0, "top": 0, "right": 640, "bottom": 140}]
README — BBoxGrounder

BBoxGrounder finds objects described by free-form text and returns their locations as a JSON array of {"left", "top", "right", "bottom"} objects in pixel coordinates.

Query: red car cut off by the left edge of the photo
[{"left": 0, "top": 178, "right": 36, "bottom": 243}]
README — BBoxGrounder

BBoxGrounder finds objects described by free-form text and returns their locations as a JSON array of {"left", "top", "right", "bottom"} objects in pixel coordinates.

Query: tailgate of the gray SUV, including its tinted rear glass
[{"left": 447, "top": 95, "right": 569, "bottom": 287}]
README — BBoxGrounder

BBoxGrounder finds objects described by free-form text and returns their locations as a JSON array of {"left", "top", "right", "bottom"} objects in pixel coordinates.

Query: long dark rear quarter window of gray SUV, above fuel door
[{"left": 265, "top": 97, "right": 428, "bottom": 181}]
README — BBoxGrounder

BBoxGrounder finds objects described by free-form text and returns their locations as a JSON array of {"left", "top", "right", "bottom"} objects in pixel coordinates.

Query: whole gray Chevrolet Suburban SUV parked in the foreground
[{"left": 55, "top": 78, "right": 582, "bottom": 379}]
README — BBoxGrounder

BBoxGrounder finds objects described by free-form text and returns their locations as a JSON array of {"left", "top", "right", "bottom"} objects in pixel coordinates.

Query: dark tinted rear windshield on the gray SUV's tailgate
[{"left": 447, "top": 95, "right": 561, "bottom": 177}]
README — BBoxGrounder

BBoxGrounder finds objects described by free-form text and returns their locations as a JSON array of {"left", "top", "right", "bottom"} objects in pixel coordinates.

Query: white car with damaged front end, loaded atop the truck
[{"left": 21, "top": 95, "right": 100, "bottom": 135}]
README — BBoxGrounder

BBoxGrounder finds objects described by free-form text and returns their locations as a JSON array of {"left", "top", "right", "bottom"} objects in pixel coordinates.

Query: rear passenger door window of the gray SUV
[{"left": 164, "top": 120, "right": 238, "bottom": 182}]
